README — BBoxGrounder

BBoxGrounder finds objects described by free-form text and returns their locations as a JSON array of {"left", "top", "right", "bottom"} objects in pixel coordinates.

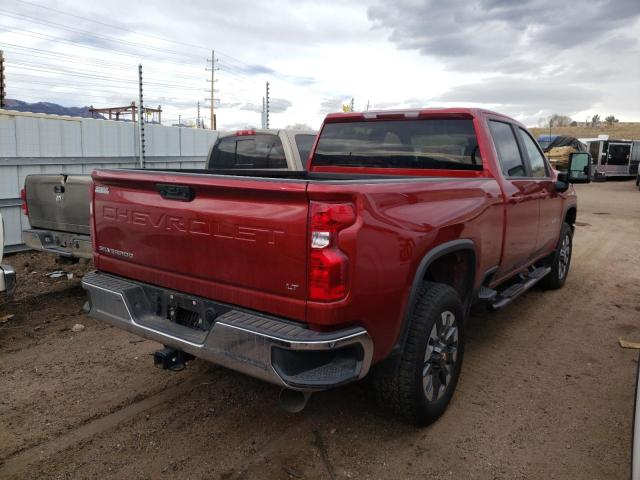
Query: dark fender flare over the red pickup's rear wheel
[{"left": 381, "top": 239, "right": 477, "bottom": 370}]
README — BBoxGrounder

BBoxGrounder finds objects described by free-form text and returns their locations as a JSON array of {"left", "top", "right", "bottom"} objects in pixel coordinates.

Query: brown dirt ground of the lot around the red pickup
[{"left": 0, "top": 182, "right": 640, "bottom": 480}]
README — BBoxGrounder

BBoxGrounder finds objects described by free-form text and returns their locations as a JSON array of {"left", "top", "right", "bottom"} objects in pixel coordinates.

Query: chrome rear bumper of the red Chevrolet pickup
[{"left": 82, "top": 272, "right": 373, "bottom": 391}]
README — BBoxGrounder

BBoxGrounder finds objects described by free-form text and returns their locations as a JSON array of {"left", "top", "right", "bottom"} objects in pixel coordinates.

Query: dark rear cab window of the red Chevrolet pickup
[{"left": 312, "top": 118, "right": 483, "bottom": 170}]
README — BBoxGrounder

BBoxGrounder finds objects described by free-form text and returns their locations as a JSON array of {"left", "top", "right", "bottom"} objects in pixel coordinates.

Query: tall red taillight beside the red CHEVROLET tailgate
[{"left": 309, "top": 202, "right": 356, "bottom": 301}]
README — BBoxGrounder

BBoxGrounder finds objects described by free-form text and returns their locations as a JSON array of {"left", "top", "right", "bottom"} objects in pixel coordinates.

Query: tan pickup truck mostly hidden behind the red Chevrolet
[{"left": 22, "top": 130, "right": 316, "bottom": 259}]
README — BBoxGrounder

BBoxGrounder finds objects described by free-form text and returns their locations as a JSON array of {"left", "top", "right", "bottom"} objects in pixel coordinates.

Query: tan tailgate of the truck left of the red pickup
[{"left": 25, "top": 174, "right": 91, "bottom": 235}]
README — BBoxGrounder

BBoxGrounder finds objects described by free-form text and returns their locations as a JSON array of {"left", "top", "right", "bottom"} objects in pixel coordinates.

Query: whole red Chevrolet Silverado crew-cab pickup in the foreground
[{"left": 83, "top": 108, "right": 590, "bottom": 425}]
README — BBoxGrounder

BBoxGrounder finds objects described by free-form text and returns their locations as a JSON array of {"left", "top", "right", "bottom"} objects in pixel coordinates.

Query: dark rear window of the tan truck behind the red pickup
[{"left": 209, "top": 134, "right": 287, "bottom": 169}]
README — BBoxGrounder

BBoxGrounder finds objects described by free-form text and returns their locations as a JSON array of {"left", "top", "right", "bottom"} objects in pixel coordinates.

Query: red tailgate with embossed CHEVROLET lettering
[{"left": 93, "top": 170, "right": 308, "bottom": 317}]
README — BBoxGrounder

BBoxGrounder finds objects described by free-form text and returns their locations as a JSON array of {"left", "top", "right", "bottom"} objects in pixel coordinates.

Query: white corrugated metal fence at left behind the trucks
[{"left": 0, "top": 110, "right": 218, "bottom": 251}]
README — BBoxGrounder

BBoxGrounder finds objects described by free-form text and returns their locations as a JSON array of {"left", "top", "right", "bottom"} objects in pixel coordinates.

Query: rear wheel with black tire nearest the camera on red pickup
[{"left": 373, "top": 282, "right": 465, "bottom": 426}]
